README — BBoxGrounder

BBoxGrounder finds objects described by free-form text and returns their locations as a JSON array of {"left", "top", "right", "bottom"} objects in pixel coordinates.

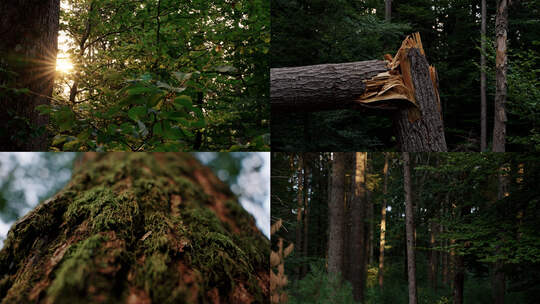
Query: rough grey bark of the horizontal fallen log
[{"left": 270, "top": 60, "right": 388, "bottom": 111}]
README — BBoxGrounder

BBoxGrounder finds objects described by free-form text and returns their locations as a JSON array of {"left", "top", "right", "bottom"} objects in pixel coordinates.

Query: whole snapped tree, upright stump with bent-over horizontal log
[{"left": 270, "top": 33, "right": 447, "bottom": 152}]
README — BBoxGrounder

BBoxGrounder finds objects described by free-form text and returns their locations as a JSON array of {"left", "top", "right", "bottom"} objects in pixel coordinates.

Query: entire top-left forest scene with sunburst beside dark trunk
[{"left": 0, "top": 0, "right": 270, "bottom": 151}]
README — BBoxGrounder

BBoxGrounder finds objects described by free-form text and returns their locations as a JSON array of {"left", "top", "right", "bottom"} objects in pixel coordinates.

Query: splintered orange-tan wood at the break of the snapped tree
[{"left": 356, "top": 33, "right": 440, "bottom": 122}]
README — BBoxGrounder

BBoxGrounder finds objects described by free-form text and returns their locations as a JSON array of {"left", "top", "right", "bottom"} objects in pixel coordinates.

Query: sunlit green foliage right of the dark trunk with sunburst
[{"left": 41, "top": 0, "right": 270, "bottom": 151}]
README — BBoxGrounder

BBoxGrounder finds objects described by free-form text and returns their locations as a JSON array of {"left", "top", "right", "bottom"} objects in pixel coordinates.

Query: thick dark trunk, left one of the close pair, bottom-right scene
[{"left": 328, "top": 152, "right": 345, "bottom": 275}]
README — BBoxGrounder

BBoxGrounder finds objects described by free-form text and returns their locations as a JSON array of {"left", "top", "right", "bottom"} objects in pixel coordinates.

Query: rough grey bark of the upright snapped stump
[{"left": 394, "top": 48, "right": 448, "bottom": 152}]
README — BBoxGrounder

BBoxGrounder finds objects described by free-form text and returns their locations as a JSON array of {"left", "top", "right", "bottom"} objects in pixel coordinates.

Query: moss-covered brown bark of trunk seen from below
[{"left": 0, "top": 153, "right": 270, "bottom": 304}]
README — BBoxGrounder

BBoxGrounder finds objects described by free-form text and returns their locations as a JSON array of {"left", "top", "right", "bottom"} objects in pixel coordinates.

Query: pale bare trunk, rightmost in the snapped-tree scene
[{"left": 493, "top": 0, "right": 508, "bottom": 152}]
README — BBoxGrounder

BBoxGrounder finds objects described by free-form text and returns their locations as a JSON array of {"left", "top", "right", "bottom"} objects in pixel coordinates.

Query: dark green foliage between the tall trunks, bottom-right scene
[{"left": 272, "top": 153, "right": 540, "bottom": 304}]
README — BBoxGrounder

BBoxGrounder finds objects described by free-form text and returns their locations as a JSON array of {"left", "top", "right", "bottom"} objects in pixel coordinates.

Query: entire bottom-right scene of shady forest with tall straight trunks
[{"left": 270, "top": 152, "right": 540, "bottom": 304}]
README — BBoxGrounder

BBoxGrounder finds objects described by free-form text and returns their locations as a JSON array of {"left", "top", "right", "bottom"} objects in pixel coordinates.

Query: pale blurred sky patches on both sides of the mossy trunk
[{"left": 0, "top": 152, "right": 270, "bottom": 247}]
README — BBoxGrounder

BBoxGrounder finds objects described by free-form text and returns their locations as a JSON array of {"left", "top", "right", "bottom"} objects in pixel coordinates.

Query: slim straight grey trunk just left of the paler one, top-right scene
[{"left": 480, "top": 0, "right": 487, "bottom": 151}]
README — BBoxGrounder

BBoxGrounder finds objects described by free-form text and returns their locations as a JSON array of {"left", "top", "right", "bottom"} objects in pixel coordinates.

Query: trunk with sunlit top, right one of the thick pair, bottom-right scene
[{"left": 349, "top": 152, "right": 367, "bottom": 303}]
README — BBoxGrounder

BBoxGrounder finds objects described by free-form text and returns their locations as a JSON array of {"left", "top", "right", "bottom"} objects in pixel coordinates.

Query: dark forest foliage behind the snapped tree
[{"left": 271, "top": 0, "right": 540, "bottom": 151}]
